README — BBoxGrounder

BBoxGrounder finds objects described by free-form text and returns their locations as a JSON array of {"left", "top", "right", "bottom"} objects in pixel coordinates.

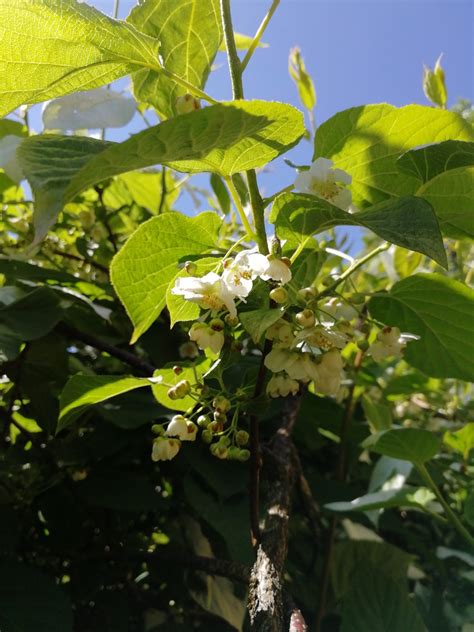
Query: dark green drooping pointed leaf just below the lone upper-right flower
[{"left": 270, "top": 193, "right": 447, "bottom": 267}]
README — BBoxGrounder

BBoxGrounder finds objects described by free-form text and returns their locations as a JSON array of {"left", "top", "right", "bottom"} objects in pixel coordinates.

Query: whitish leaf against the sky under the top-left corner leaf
[{"left": 42, "top": 88, "right": 137, "bottom": 131}]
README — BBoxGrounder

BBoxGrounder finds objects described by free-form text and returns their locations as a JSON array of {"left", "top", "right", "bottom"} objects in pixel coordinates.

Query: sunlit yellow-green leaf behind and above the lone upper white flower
[{"left": 314, "top": 103, "right": 474, "bottom": 206}]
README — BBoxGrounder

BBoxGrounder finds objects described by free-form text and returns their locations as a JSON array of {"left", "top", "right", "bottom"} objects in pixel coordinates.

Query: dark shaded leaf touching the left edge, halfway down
[{"left": 0, "top": 287, "right": 61, "bottom": 340}]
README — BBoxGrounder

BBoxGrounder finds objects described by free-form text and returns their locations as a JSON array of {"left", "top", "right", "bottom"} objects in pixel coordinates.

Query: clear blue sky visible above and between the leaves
[{"left": 26, "top": 0, "right": 474, "bottom": 249}]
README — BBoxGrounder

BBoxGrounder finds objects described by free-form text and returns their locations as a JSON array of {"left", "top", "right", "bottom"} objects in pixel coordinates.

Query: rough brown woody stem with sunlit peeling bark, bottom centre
[{"left": 248, "top": 397, "right": 301, "bottom": 632}]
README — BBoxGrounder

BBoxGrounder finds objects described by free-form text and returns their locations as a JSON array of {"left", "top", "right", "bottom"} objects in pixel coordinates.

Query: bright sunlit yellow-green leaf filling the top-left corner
[{"left": 0, "top": 0, "right": 161, "bottom": 117}]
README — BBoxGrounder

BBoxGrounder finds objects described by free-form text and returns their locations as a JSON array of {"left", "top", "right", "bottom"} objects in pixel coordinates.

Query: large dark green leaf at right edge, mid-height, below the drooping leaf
[{"left": 369, "top": 274, "right": 474, "bottom": 381}]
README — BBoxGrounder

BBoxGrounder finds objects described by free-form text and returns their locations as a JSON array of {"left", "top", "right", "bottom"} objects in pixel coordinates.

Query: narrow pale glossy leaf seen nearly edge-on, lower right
[{"left": 324, "top": 487, "right": 435, "bottom": 512}]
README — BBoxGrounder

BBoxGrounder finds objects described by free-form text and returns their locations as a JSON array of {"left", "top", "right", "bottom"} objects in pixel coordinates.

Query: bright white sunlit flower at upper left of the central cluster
[{"left": 171, "top": 272, "right": 237, "bottom": 316}]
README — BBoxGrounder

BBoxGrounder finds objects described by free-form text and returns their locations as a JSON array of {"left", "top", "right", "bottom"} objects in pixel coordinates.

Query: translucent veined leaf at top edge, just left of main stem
[{"left": 127, "top": 0, "right": 222, "bottom": 118}]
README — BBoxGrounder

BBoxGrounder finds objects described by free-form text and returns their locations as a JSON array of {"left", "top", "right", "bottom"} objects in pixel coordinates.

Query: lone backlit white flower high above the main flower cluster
[{"left": 295, "top": 158, "right": 352, "bottom": 211}]
